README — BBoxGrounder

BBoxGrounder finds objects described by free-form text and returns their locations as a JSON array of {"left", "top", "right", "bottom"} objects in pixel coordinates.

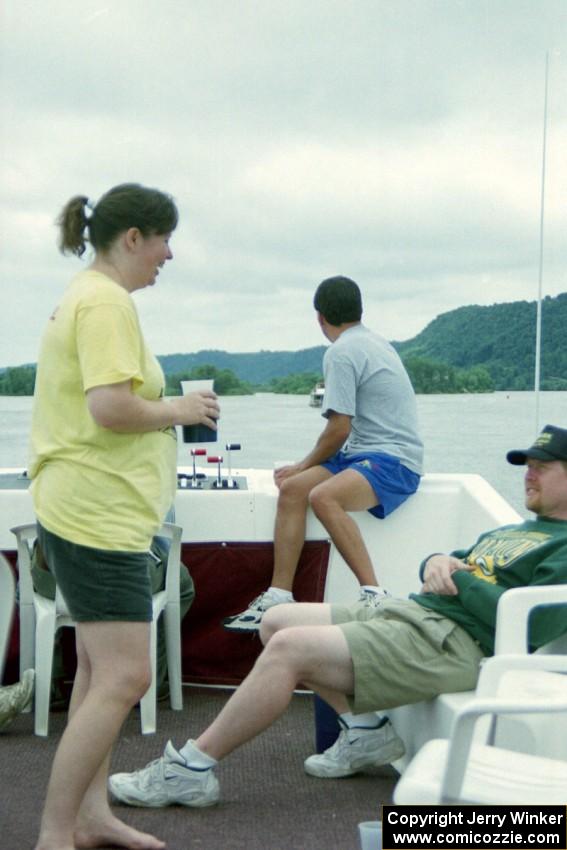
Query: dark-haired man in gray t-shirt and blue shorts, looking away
[{"left": 223, "top": 277, "right": 423, "bottom": 632}]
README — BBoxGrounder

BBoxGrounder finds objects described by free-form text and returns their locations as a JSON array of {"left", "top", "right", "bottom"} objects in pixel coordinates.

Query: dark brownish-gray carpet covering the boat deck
[{"left": 0, "top": 687, "right": 396, "bottom": 850}]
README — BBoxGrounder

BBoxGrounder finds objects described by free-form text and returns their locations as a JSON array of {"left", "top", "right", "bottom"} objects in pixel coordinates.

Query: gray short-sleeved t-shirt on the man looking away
[{"left": 322, "top": 324, "right": 423, "bottom": 475}]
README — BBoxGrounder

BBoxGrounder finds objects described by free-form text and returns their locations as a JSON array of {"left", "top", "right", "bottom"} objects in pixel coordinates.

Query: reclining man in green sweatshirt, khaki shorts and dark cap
[{"left": 109, "top": 425, "right": 567, "bottom": 806}]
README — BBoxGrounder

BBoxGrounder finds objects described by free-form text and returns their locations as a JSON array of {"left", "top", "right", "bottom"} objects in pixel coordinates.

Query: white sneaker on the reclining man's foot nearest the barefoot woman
[{"left": 108, "top": 741, "right": 220, "bottom": 808}]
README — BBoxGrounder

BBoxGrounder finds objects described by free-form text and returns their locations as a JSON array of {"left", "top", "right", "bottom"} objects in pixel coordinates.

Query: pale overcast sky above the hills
[{"left": 0, "top": 0, "right": 567, "bottom": 366}]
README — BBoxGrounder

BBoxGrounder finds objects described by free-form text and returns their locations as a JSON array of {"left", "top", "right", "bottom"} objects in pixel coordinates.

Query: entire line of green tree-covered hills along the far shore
[{"left": 0, "top": 293, "right": 567, "bottom": 395}]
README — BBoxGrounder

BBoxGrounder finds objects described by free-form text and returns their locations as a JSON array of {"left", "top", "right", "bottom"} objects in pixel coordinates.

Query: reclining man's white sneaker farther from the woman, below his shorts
[{"left": 303, "top": 717, "right": 406, "bottom": 779}]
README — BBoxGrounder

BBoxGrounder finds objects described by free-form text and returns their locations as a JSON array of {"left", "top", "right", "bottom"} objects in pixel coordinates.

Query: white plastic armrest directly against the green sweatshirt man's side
[{"left": 494, "top": 584, "right": 567, "bottom": 655}]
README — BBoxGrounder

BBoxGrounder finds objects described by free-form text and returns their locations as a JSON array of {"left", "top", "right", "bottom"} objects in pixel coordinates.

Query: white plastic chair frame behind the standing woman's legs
[{"left": 11, "top": 523, "right": 183, "bottom": 736}]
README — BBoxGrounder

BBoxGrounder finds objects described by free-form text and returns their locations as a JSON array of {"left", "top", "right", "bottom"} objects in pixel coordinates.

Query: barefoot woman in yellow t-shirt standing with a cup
[{"left": 30, "top": 184, "right": 219, "bottom": 850}]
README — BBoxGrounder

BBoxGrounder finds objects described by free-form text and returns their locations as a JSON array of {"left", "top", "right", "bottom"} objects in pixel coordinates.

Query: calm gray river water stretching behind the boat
[{"left": 0, "top": 392, "right": 567, "bottom": 516}]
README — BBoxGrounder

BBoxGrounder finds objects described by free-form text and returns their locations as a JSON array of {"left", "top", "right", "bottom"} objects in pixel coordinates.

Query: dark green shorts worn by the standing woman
[{"left": 38, "top": 523, "right": 152, "bottom": 623}]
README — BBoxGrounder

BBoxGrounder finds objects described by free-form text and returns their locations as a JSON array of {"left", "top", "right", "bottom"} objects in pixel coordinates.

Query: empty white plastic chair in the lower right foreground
[{"left": 394, "top": 655, "right": 567, "bottom": 805}]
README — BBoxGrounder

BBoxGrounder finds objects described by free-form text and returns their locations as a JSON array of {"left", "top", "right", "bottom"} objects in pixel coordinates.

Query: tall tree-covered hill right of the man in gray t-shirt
[{"left": 394, "top": 293, "right": 567, "bottom": 390}]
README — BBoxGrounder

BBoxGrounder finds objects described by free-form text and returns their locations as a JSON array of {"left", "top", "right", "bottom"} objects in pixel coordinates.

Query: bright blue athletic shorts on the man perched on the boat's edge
[{"left": 321, "top": 452, "right": 420, "bottom": 519}]
